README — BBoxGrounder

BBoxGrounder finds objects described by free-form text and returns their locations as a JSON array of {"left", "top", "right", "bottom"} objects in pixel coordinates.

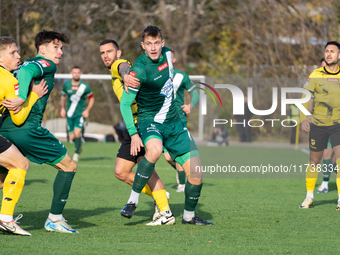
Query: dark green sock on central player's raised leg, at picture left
[{"left": 132, "top": 157, "right": 155, "bottom": 193}]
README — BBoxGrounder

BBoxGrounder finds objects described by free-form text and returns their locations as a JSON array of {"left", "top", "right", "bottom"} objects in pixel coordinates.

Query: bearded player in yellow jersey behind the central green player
[{"left": 99, "top": 40, "right": 173, "bottom": 223}]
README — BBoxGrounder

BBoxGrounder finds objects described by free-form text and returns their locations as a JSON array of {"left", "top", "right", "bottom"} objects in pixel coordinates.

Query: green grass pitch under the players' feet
[{"left": 0, "top": 143, "right": 340, "bottom": 255}]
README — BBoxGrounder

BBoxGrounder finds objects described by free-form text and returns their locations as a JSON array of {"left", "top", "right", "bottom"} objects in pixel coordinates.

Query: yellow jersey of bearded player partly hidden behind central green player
[{"left": 111, "top": 59, "right": 138, "bottom": 123}]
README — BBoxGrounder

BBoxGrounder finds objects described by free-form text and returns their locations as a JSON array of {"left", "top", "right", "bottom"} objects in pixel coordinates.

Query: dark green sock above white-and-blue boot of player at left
[{"left": 50, "top": 171, "right": 75, "bottom": 214}]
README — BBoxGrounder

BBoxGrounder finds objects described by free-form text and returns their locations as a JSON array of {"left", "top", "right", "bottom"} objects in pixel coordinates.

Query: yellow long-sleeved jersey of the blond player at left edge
[{"left": 0, "top": 66, "right": 39, "bottom": 126}]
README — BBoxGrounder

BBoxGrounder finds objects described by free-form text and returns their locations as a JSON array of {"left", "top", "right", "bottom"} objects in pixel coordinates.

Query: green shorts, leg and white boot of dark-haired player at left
[{"left": 9, "top": 127, "right": 77, "bottom": 233}]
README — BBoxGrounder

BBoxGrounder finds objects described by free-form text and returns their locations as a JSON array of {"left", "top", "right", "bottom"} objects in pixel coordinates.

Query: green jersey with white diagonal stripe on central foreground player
[{"left": 129, "top": 47, "right": 180, "bottom": 125}]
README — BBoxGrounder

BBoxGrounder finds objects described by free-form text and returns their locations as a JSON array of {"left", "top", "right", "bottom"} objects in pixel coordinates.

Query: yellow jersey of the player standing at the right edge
[{"left": 303, "top": 67, "right": 340, "bottom": 126}]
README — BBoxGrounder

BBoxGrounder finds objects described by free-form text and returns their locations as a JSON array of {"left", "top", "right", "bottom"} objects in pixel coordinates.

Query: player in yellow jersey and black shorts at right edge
[{"left": 300, "top": 41, "right": 340, "bottom": 211}]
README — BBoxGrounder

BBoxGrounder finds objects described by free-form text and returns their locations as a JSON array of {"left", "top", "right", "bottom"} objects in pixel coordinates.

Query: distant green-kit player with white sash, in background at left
[{"left": 60, "top": 66, "right": 94, "bottom": 162}]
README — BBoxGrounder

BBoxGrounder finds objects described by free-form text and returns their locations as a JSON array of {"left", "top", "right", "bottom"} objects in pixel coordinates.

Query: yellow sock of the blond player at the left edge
[{"left": 0, "top": 168, "right": 27, "bottom": 215}]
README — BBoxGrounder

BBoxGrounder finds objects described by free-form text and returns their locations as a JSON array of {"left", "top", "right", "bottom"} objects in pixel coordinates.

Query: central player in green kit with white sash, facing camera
[{"left": 120, "top": 25, "right": 213, "bottom": 225}]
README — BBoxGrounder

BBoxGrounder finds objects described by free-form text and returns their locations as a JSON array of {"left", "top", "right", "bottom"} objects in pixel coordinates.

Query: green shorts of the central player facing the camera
[{"left": 139, "top": 121, "right": 199, "bottom": 163}]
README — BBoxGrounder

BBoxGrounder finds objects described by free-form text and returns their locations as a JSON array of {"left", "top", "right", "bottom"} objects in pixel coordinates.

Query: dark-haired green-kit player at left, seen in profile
[{"left": 0, "top": 30, "right": 78, "bottom": 233}]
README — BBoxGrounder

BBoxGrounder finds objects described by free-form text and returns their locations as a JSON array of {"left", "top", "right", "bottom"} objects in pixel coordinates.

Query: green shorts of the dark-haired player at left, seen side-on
[{"left": 0, "top": 127, "right": 67, "bottom": 166}]
